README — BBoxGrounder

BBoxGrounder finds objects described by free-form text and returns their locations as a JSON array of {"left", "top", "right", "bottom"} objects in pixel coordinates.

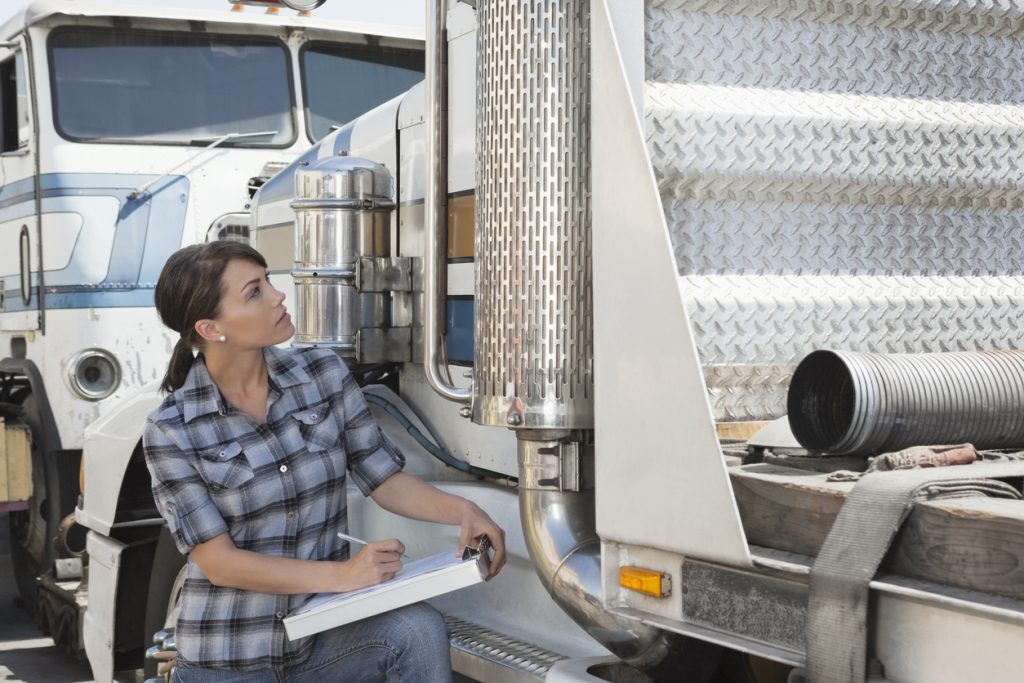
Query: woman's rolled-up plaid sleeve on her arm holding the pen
[{"left": 142, "top": 420, "right": 227, "bottom": 555}]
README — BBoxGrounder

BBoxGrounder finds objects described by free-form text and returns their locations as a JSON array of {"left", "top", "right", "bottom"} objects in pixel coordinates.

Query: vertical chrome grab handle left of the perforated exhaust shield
[{"left": 423, "top": 0, "right": 472, "bottom": 403}]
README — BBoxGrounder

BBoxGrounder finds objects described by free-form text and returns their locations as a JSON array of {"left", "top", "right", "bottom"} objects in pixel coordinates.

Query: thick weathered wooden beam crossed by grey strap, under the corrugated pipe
[{"left": 729, "top": 465, "right": 1024, "bottom": 599}]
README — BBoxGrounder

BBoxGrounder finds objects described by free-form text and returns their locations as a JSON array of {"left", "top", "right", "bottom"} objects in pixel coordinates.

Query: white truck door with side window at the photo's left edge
[{"left": 0, "top": 38, "right": 39, "bottom": 331}]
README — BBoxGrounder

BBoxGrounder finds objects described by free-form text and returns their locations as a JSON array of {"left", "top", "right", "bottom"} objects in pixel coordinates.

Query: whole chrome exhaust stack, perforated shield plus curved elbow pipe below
[{"left": 468, "top": 0, "right": 674, "bottom": 669}]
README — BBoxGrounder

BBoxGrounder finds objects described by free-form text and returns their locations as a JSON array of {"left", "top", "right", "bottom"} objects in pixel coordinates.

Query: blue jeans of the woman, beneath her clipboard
[{"left": 174, "top": 603, "right": 452, "bottom": 683}]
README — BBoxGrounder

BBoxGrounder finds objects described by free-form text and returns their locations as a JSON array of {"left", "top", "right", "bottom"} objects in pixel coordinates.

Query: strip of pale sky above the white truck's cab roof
[{"left": 0, "top": 0, "right": 426, "bottom": 26}]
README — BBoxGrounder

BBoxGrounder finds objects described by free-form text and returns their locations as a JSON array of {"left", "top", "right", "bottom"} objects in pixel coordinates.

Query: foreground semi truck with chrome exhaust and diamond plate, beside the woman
[{"left": 79, "top": 0, "right": 1024, "bottom": 683}]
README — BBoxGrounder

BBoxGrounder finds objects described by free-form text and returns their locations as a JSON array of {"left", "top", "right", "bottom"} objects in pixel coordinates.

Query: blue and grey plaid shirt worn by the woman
[{"left": 142, "top": 347, "right": 404, "bottom": 671}]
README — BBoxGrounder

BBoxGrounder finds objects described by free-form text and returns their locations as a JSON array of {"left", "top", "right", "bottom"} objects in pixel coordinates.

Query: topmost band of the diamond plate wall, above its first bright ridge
[{"left": 647, "top": 2, "right": 1024, "bottom": 101}]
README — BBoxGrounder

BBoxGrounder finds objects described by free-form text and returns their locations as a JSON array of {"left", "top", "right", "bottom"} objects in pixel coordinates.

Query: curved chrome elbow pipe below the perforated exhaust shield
[{"left": 518, "top": 432, "right": 673, "bottom": 669}]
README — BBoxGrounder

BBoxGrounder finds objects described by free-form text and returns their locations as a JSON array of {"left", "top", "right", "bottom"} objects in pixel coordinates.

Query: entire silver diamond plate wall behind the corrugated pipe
[{"left": 645, "top": 0, "right": 1024, "bottom": 420}]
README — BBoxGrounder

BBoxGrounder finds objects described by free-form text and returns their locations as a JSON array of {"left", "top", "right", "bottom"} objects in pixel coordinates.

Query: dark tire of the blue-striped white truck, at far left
[{"left": 8, "top": 395, "right": 72, "bottom": 614}]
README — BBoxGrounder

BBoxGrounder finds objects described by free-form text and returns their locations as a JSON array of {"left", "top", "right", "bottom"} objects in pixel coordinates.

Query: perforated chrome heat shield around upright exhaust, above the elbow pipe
[{"left": 473, "top": 0, "right": 593, "bottom": 428}]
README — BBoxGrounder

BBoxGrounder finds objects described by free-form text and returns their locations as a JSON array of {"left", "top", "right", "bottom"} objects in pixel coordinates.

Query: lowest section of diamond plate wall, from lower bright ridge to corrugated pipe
[{"left": 681, "top": 275, "right": 1024, "bottom": 420}]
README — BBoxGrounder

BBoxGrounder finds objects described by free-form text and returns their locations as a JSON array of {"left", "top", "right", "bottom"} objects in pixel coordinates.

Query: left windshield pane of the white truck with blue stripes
[{"left": 49, "top": 27, "right": 295, "bottom": 146}]
